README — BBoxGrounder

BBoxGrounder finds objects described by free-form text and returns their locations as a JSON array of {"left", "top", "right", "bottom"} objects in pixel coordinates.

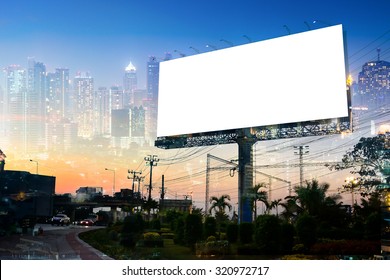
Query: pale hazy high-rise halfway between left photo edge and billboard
[{"left": 73, "top": 72, "right": 96, "bottom": 138}]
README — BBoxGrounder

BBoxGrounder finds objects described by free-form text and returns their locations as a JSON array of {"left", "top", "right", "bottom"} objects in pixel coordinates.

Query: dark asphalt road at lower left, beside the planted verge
[{"left": 0, "top": 224, "right": 110, "bottom": 260}]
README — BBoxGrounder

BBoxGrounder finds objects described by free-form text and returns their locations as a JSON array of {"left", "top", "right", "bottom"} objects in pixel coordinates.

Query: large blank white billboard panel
[{"left": 157, "top": 25, "right": 348, "bottom": 137}]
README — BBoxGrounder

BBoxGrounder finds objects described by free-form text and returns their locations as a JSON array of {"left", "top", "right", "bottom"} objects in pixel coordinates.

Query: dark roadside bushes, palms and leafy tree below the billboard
[{"left": 80, "top": 134, "right": 390, "bottom": 259}]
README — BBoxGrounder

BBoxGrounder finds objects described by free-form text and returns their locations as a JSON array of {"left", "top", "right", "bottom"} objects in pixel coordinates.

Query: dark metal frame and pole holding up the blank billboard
[{"left": 155, "top": 25, "right": 353, "bottom": 223}]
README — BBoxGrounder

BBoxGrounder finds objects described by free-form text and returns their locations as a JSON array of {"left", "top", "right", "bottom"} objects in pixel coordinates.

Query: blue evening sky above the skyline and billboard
[{"left": 0, "top": 0, "right": 390, "bottom": 88}]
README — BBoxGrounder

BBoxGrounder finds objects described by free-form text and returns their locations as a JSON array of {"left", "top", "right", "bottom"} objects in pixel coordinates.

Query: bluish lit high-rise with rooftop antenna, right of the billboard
[{"left": 356, "top": 50, "right": 390, "bottom": 110}]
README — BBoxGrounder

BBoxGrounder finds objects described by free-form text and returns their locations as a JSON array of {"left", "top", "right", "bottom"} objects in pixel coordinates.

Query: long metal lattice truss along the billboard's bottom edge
[{"left": 155, "top": 118, "right": 352, "bottom": 149}]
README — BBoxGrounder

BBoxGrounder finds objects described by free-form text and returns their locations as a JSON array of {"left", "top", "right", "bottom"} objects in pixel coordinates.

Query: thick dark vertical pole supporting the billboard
[{"left": 237, "top": 128, "right": 256, "bottom": 224}]
